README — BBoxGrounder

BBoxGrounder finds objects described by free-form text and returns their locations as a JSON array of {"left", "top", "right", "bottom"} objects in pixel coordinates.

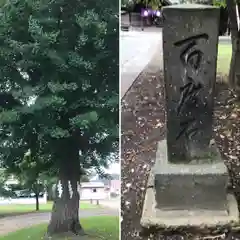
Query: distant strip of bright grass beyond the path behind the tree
[{"left": 0, "top": 202, "right": 99, "bottom": 218}]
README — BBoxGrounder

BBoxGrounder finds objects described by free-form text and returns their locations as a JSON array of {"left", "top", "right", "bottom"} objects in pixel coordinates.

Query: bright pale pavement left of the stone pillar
[{"left": 120, "top": 31, "right": 162, "bottom": 98}]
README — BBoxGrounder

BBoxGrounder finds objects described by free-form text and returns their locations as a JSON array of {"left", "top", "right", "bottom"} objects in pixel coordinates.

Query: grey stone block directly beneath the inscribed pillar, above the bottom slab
[{"left": 153, "top": 140, "right": 228, "bottom": 211}]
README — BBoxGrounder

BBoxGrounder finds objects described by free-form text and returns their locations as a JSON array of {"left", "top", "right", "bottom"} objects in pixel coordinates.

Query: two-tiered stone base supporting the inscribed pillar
[{"left": 141, "top": 140, "right": 239, "bottom": 228}]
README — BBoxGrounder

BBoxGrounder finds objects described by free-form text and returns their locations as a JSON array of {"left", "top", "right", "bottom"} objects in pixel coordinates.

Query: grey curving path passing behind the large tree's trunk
[{"left": 0, "top": 208, "right": 119, "bottom": 236}]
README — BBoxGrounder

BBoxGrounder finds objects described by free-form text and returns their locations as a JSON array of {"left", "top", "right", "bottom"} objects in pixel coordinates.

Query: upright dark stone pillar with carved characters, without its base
[{"left": 163, "top": 4, "right": 219, "bottom": 162}]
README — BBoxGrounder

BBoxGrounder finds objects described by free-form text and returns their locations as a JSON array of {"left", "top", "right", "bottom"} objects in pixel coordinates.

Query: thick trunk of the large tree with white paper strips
[{"left": 48, "top": 148, "right": 84, "bottom": 236}]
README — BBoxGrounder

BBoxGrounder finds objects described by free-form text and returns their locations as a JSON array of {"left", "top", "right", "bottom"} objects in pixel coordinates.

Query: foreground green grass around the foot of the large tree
[{"left": 0, "top": 216, "right": 119, "bottom": 240}]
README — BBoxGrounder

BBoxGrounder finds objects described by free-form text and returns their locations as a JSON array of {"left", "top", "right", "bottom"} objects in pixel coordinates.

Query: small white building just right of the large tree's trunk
[{"left": 80, "top": 182, "right": 108, "bottom": 200}]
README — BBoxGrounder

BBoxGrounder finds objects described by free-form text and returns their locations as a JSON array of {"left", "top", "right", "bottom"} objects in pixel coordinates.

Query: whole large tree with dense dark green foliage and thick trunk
[{"left": 0, "top": 0, "right": 119, "bottom": 235}]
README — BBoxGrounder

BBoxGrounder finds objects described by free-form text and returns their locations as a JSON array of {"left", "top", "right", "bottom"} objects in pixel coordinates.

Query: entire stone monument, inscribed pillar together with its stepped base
[{"left": 141, "top": 4, "right": 239, "bottom": 227}]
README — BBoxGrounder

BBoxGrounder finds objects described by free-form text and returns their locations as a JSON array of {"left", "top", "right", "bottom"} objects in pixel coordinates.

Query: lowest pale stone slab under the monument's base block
[{"left": 140, "top": 183, "right": 239, "bottom": 230}]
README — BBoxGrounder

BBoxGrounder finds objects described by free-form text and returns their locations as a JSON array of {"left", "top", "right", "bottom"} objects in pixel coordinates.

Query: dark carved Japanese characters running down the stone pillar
[{"left": 174, "top": 34, "right": 209, "bottom": 140}]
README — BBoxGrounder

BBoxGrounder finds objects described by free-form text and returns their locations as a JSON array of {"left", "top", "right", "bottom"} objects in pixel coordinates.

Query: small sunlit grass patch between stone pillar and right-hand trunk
[{"left": 217, "top": 44, "right": 232, "bottom": 76}]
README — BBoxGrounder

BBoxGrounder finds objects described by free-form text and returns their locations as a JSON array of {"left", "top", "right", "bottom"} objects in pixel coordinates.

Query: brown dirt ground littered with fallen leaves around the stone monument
[{"left": 121, "top": 55, "right": 240, "bottom": 240}]
